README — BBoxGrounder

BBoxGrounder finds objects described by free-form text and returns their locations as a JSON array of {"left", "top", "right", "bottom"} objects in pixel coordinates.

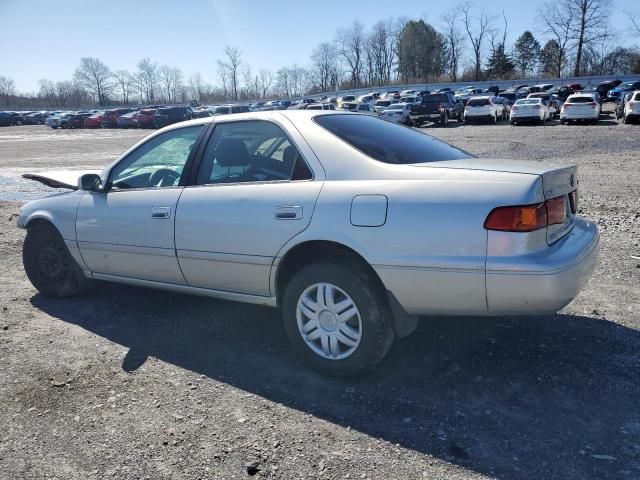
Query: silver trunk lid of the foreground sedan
[{"left": 414, "top": 158, "right": 578, "bottom": 245}]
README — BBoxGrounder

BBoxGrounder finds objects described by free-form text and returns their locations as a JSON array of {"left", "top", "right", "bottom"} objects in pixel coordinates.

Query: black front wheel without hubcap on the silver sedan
[{"left": 22, "top": 223, "right": 89, "bottom": 298}]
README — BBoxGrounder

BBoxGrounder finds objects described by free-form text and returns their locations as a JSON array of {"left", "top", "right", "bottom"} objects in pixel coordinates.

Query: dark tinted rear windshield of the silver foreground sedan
[{"left": 315, "top": 115, "right": 472, "bottom": 165}]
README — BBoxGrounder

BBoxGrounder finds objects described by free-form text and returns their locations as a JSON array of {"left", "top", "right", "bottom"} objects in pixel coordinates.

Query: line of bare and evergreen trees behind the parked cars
[{"left": 0, "top": 0, "right": 640, "bottom": 108}]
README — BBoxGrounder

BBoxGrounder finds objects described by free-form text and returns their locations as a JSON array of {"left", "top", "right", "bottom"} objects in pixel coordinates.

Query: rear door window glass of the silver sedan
[{"left": 197, "top": 120, "right": 312, "bottom": 185}]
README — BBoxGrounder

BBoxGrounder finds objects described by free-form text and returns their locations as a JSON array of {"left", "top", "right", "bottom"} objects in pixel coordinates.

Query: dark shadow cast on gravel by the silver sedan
[{"left": 32, "top": 285, "right": 640, "bottom": 479}]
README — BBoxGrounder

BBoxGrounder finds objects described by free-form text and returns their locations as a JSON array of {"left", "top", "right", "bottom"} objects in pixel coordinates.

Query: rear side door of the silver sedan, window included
[{"left": 175, "top": 120, "right": 323, "bottom": 296}]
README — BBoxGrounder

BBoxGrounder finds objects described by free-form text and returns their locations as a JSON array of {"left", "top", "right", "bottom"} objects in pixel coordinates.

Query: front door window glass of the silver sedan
[{"left": 109, "top": 125, "right": 203, "bottom": 189}]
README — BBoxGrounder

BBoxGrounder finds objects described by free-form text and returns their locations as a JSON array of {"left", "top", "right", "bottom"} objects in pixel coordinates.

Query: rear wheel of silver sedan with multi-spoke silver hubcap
[{"left": 282, "top": 263, "right": 394, "bottom": 377}]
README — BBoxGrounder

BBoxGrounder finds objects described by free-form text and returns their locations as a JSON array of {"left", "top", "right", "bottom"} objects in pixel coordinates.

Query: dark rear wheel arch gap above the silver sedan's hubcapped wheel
[{"left": 273, "top": 240, "right": 417, "bottom": 337}]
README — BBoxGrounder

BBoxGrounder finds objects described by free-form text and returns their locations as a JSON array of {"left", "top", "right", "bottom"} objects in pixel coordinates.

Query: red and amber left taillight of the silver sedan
[{"left": 484, "top": 196, "right": 567, "bottom": 232}]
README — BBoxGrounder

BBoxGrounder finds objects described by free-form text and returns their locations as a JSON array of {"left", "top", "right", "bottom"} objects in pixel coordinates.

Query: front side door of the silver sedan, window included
[{"left": 76, "top": 125, "right": 203, "bottom": 284}]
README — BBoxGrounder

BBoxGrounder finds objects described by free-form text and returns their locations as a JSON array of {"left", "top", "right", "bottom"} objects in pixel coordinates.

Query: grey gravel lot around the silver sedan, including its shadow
[{"left": 0, "top": 120, "right": 640, "bottom": 480}]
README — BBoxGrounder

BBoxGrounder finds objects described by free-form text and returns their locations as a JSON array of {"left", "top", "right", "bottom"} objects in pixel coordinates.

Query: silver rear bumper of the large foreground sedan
[{"left": 486, "top": 218, "right": 600, "bottom": 315}]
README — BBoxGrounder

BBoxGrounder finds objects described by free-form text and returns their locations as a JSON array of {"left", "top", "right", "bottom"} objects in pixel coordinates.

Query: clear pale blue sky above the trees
[{"left": 0, "top": 0, "right": 640, "bottom": 91}]
